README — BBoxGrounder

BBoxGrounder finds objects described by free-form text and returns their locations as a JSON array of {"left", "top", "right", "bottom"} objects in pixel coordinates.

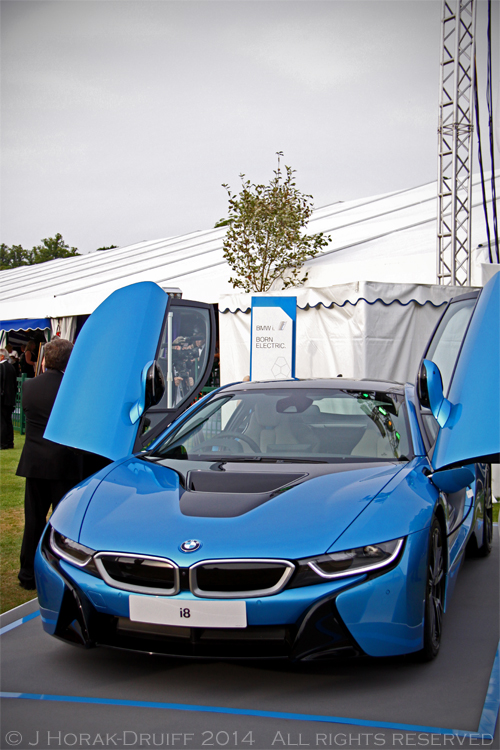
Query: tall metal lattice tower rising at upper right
[{"left": 437, "top": 0, "right": 476, "bottom": 286}]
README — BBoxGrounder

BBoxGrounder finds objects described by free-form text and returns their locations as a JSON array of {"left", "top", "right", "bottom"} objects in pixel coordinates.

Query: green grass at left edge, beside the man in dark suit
[{"left": 0, "top": 432, "right": 500, "bottom": 612}]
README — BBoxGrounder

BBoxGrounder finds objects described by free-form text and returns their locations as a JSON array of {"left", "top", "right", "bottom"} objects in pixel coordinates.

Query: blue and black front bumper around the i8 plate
[{"left": 36, "top": 532, "right": 427, "bottom": 661}]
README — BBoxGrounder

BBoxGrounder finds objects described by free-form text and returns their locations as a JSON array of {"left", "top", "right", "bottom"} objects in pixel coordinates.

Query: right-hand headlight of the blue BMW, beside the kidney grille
[{"left": 291, "top": 538, "right": 404, "bottom": 587}]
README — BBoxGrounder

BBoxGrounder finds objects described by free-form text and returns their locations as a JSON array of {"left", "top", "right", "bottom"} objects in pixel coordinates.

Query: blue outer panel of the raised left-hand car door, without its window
[{"left": 45, "top": 281, "right": 168, "bottom": 460}]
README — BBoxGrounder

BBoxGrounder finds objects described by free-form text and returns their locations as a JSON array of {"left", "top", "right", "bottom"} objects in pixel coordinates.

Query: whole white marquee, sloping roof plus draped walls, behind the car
[{"left": 0, "top": 171, "right": 500, "bottom": 488}]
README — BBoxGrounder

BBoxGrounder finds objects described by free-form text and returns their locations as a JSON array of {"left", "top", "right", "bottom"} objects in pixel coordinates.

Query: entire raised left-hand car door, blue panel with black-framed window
[{"left": 45, "top": 282, "right": 215, "bottom": 460}]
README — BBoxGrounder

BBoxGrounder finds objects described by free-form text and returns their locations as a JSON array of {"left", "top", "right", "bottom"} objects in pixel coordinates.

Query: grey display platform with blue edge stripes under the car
[{"left": 0, "top": 526, "right": 500, "bottom": 750}]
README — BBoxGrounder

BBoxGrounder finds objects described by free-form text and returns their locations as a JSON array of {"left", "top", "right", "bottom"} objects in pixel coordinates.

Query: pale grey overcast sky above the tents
[{"left": 0, "top": 0, "right": 500, "bottom": 253}]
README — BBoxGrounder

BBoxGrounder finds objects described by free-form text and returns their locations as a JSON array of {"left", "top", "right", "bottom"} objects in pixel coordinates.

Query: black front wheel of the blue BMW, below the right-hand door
[{"left": 419, "top": 518, "right": 446, "bottom": 661}]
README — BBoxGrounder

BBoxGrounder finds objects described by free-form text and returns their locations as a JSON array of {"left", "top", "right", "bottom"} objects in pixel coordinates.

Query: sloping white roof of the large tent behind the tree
[{"left": 0, "top": 171, "right": 500, "bottom": 320}]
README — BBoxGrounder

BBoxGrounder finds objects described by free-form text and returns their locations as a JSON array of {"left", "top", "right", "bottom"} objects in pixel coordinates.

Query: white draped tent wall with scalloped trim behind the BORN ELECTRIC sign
[{"left": 219, "top": 281, "right": 474, "bottom": 383}]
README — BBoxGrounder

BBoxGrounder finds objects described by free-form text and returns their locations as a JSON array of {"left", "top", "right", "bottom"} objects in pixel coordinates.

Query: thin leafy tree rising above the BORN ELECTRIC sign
[{"left": 218, "top": 151, "right": 330, "bottom": 292}]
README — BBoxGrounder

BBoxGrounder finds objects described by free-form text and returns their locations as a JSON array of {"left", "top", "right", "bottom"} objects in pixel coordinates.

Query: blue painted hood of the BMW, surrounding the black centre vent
[{"left": 76, "top": 458, "right": 405, "bottom": 565}]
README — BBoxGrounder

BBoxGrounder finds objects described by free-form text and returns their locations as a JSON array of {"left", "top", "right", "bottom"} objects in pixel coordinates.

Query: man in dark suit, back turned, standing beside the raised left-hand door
[{"left": 16, "top": 338, "right": 81, "bottom": 590}]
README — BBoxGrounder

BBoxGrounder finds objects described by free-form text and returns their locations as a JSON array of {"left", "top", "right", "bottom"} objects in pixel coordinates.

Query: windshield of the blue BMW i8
[{"left": 152, "top": 388, "right": 411, "bottom": 461}]
